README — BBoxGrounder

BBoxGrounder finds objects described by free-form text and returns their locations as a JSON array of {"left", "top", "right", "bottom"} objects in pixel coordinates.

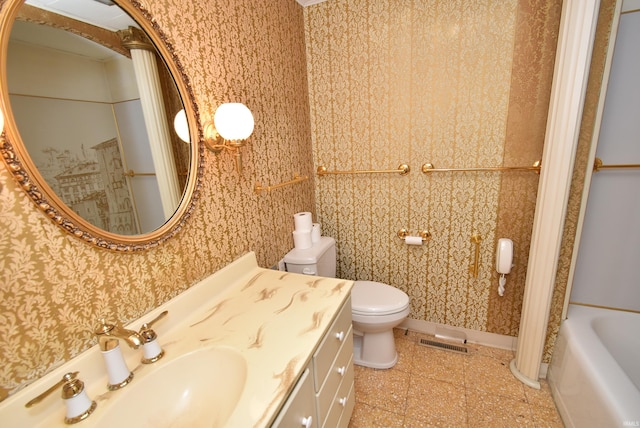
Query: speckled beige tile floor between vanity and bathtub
[{"left": 349, "top": 329, "right": 563, "bottom": 428}]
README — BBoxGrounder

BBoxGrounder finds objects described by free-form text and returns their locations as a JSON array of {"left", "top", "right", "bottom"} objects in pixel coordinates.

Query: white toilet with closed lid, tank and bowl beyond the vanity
[{"left": 284, "top": 236, "right": 409, "bottom": 369}]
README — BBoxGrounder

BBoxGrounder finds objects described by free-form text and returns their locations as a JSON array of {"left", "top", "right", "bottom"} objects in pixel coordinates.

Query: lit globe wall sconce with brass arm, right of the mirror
[{"left": 204, "top": 103, "right": 254, "bottom": 173}]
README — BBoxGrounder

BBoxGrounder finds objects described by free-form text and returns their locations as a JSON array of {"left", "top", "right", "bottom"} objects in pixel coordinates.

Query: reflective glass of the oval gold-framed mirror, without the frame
[{"left": 7, "top": 5, "right": 188, "bottom": 235}]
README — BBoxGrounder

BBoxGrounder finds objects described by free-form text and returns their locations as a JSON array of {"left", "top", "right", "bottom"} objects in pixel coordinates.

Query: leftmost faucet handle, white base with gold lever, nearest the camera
[{"left": 24, "top": 372, "right": 98, "bottom": 424}]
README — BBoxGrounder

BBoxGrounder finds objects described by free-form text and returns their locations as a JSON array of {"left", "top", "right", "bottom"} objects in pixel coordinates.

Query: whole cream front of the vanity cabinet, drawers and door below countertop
[{"left": 273, "top": 299, "right": 355, "bottom": 428}]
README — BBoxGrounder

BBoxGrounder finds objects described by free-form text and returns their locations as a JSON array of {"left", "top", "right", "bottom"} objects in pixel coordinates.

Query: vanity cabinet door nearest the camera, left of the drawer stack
[{"left": 272, "top": 368, "right": 318, "bottom": 428}]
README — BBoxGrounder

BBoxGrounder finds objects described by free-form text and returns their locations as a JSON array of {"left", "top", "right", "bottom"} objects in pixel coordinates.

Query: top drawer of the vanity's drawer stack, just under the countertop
[{"left": 313, "top": 298, "right": 351, "bottom": 392}]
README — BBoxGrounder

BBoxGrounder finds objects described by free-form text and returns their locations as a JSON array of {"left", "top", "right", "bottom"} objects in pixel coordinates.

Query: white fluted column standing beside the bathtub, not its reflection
[{"left": 510, "top": 0, "right": 600, "bottom": 388}]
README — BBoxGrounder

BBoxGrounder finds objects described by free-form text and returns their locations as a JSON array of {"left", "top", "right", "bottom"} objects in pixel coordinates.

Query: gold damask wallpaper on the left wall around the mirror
[{"left": 0, "top": 0, "right": 315, "bottom": 399}]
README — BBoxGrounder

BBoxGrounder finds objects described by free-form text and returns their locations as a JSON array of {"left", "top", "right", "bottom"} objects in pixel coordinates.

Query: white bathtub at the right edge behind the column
[{"left": 547, "top": 305, "right": 640, "bottom": 428}]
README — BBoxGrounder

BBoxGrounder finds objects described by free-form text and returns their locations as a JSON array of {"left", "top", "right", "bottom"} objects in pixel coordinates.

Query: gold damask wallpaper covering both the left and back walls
[{"left": 0, "top": 0, "right": 561, "bottom": 399}]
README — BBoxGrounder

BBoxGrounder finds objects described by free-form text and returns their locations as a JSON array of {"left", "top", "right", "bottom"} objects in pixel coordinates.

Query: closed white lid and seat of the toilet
[{"left": 351, "top": 281, "right": 409, "bottom": 316}]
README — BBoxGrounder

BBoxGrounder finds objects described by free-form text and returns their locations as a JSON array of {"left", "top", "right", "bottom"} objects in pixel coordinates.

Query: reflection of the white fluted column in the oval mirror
[{"left": 121, "top": 28, "right": 182, "bottom": 220}]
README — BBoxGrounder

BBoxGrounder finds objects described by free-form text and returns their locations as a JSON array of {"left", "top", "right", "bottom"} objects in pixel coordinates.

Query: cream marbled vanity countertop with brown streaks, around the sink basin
[{"left": 0, "top": 253, "right": 353, "bottom": 428}]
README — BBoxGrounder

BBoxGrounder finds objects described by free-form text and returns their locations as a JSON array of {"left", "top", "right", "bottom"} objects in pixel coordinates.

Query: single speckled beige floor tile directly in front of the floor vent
[{"left": 411, "top": 345, "right": 468, "bottom": 387}]
